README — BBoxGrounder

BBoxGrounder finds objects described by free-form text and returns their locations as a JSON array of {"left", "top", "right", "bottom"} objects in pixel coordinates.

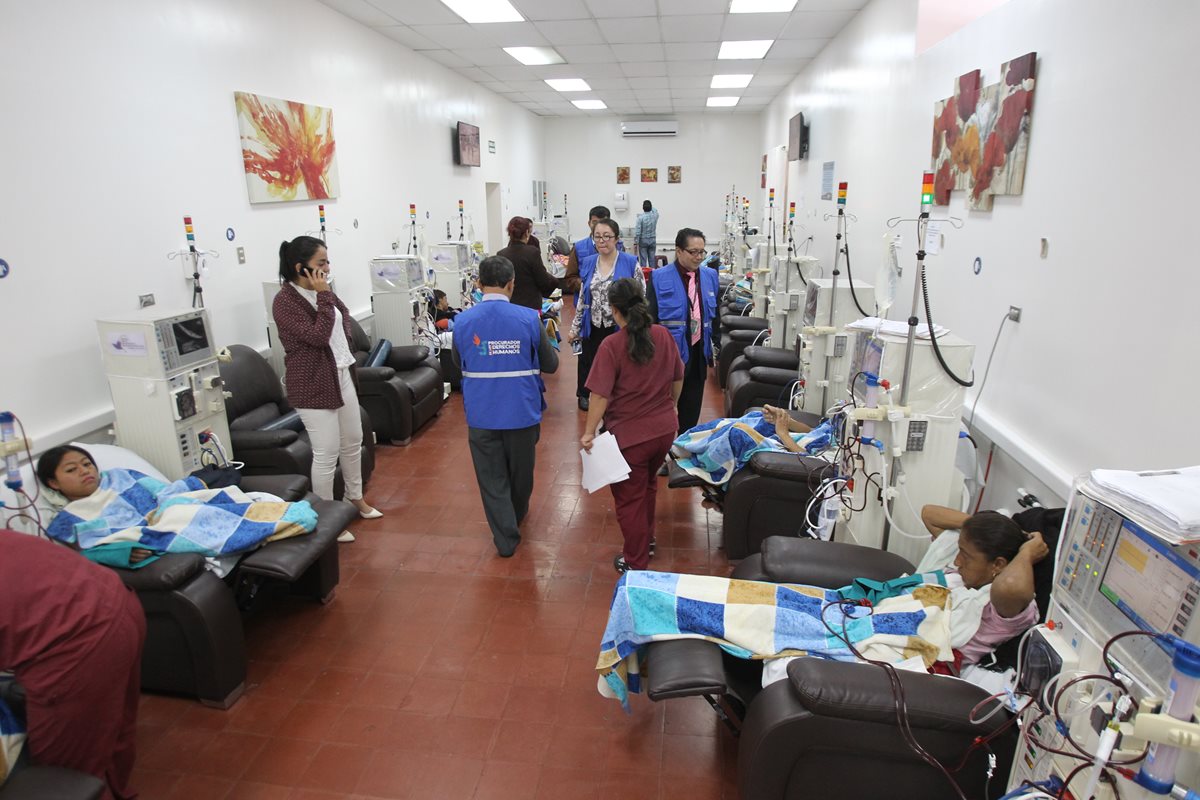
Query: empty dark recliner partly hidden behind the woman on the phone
[{"left": 220, "top": 344, "right": 374, "bottom": 498}]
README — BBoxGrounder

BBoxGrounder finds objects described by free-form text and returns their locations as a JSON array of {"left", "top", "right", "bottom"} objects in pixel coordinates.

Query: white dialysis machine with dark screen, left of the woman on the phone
[{"left": 96, "top": 308, "right": 233, "bottom": 480}]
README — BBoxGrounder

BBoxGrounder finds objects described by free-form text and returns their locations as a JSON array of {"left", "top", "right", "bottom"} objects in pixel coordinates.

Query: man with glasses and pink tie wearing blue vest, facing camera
[{"left": 646, "top": 228, "right": 720, "bottom": 443}]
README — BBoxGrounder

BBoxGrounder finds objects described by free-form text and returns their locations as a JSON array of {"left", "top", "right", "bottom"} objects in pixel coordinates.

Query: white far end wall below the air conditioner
[{"left": 546, "top": 114, "right": 762, "bottom": 243}]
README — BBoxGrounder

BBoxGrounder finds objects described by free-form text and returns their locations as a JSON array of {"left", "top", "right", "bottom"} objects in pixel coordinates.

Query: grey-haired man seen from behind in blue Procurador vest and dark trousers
[{"left": 454, "top": 255, "right": 558, "bottom": 558}]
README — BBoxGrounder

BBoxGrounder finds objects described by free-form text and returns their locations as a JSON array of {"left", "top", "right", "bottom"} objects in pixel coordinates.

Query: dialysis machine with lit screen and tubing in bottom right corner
[{"left": 1006, "top": 479, "right": 1200, "bottom": 800}]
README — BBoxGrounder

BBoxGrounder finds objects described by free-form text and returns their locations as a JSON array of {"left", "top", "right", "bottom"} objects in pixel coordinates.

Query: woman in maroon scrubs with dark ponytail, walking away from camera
[{"left": 580, "top": 278, "right": 683, "bottom": 572}]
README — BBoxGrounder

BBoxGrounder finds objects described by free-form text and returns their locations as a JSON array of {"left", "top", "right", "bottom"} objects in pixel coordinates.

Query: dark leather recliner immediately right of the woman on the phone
[{"left": 350, "top": 318, "right": 444, "bottom": 446}]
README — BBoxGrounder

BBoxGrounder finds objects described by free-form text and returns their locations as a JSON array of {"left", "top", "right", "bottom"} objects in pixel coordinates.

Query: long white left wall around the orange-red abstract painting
[{"left": 0, "top": 0, "right": 542, "bottom": 446}]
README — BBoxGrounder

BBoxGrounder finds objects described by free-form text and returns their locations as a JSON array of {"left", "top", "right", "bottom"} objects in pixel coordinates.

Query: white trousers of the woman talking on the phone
[{"left": 296, "top": 367, "right": 362, "bottom": 500}]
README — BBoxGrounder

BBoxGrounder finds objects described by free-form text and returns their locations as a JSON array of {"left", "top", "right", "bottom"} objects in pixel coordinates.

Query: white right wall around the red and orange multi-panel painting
[{"left": 763, "top": 0, "right": 1200, "bottom": 506}]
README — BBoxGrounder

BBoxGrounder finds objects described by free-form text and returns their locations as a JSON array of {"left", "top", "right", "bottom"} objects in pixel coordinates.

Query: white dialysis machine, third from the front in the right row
[{"left": 801, "top": 280, "right": 875, "bottom": 416}]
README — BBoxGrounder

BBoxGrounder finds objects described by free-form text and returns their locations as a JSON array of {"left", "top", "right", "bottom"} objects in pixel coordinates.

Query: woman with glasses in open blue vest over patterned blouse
[{"left": 566, "top": 219, "right": 644, "bottom": 411}]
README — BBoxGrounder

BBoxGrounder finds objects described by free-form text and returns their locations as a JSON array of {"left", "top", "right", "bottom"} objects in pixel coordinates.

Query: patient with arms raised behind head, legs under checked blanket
[{"left": 596, "top": 506, "right": 1049, "bottom": 710}]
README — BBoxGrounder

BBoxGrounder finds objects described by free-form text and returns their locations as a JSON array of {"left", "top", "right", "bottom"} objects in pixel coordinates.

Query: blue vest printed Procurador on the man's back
[{"left": 454, "top": 300, "right": 545, "bottom": 431}]
